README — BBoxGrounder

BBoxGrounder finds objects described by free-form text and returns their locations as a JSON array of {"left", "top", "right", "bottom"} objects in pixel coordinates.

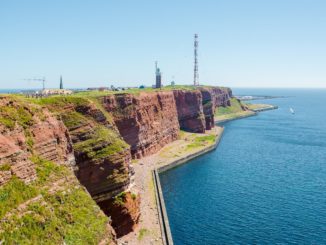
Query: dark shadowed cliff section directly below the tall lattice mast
[{"left": 173, "top": 90, "right": 205, "bottom": 133}]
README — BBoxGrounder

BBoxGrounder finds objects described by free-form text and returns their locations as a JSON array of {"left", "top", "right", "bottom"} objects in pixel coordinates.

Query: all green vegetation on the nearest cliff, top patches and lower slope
[{"left": 0, "top": 96, "right": 113, "bottom": 244}]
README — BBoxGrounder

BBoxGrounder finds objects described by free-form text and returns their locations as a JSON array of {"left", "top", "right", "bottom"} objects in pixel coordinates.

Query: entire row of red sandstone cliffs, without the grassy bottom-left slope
[{"left": 0, "top": 87, "right": 232, "bottom": 241}]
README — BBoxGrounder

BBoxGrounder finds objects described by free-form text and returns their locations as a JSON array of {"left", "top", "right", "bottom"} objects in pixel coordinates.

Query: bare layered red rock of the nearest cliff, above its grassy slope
[{"left": 0, "top": 98, "right": 74, "bottom": 185}]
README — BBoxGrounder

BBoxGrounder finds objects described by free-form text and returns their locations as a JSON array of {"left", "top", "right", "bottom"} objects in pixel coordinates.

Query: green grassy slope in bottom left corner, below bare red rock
[{"left": 0, "top": 156, "right": 108, "bottom": 244}]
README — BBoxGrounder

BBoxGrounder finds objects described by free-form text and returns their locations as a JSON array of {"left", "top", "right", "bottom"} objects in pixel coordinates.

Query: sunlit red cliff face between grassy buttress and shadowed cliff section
[{"left": 103, "top": 92, "right": 179, "bottom": 158}]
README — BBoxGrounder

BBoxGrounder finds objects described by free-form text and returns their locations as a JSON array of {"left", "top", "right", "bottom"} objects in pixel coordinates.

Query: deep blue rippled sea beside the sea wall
[{"left": 160, "top": 90, "right": 326, "bottom": 245}]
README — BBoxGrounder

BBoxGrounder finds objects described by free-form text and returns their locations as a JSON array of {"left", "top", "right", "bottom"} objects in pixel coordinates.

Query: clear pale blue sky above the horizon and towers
[{"left": 0, "top": 0, "right": 326, "bottom": 88}]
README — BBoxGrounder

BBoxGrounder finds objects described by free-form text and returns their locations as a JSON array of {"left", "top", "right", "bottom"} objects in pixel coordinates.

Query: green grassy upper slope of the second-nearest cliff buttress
[{"left": 26, "top": 93, "right": 129, "bottom": 159}]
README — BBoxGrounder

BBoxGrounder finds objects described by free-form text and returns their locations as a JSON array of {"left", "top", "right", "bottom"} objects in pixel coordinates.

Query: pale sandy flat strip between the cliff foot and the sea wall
[{"left": 118, "top": 126, "right": 223, "bottom": 245}]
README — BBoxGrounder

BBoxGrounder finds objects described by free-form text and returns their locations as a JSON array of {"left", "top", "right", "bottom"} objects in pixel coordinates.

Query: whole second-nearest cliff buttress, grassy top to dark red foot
[{"left": 46, "top": 99, "right": 140, "bottom": 239}]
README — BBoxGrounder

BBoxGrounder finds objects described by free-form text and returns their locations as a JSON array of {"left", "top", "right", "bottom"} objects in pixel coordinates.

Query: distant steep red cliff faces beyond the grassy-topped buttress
[{"left": 102, "top": 87, "right": 232, "bottom": 158}]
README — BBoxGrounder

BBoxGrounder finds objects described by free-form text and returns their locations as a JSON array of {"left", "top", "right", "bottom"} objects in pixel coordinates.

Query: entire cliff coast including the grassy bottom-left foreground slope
[{"left": 0, "top": 87, "right": 232, "bottom": 244}]
